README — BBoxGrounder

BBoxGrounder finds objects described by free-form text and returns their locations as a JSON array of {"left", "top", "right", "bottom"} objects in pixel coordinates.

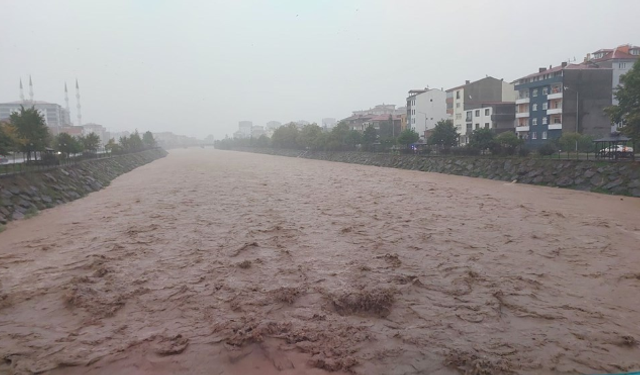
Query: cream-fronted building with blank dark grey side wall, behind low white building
[{"left": 447, "top": 77, "right": 516, "bottom": 134}]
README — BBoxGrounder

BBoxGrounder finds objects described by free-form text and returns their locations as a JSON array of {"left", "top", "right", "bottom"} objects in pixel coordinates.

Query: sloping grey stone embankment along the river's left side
[{"left": 0, "top": 149, "right": 167, "bottom": 224}]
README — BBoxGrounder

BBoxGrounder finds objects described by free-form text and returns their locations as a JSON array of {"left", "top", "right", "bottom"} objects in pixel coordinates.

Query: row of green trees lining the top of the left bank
[{"left": 0, "top": 107, "right": 156, "bottom": 161}]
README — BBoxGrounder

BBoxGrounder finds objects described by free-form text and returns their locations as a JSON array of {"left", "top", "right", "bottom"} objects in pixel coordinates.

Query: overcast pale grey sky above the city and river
[{"left": 0, "top": 0, "right": 640, "bottom": 138}]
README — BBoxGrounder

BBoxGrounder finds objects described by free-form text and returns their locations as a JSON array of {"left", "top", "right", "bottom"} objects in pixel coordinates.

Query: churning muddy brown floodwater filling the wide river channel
[{"left": 0, "top": 149, "right": 640, "bottom": 375}]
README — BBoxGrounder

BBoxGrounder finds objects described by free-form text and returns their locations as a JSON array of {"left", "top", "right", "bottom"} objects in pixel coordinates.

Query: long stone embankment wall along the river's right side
[{"left": 238, "top": 149, "right": 640, "bottom": 197}]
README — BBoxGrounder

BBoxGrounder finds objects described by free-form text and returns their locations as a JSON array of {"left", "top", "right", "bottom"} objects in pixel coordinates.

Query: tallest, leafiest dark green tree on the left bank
[{"left": 10, "top": 106, "right": 50, "bottom": 160}]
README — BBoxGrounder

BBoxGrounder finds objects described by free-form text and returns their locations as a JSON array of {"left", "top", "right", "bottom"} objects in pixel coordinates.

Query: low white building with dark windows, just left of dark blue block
[{"left": 460, "top": 102, "right": 516, "bottom": 144}]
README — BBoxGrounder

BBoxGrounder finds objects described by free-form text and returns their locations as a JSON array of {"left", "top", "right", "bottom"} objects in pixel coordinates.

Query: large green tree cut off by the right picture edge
[{"left": 605, "top": 60, "right": 640, "bottom": 144}]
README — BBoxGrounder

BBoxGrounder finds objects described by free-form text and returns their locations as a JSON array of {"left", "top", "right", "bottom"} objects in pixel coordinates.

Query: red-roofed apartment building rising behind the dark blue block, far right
[{"left": 585, "top": 44, "right": 640, "bottom": 104}]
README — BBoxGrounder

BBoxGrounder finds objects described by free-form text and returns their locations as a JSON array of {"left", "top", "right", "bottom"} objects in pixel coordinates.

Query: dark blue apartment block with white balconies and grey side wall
[{"left": 515, "top": 63, "right": 612, "bottom": 145}]
